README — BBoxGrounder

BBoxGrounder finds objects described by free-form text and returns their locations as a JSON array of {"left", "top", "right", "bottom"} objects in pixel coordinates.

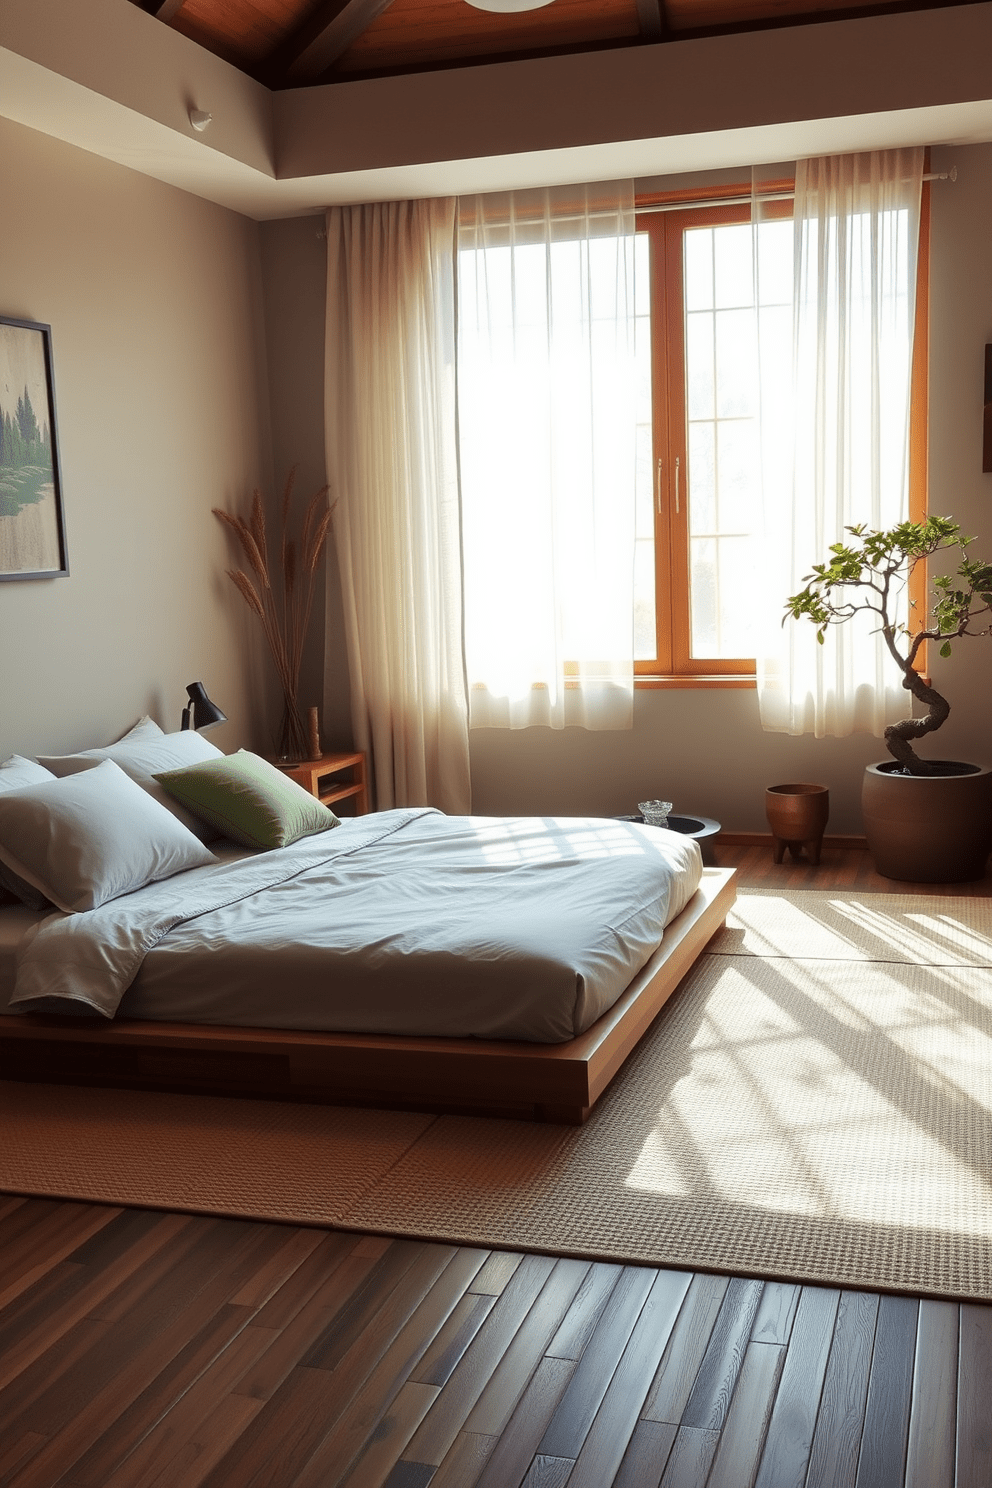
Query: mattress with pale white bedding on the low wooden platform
[{"left": 0, "top": 809, "right": 702, "bottom": 1043}]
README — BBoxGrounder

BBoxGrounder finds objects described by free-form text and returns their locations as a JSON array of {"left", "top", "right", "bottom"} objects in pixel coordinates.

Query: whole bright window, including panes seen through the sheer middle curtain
[{"left": 458, "top": 182, "right": 928, "bottom": 695}]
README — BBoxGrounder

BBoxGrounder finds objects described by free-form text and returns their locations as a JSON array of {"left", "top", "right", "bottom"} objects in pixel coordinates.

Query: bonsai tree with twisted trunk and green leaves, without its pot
[{"left": 785, "top": 516, "right": 992, "bottom": 775}]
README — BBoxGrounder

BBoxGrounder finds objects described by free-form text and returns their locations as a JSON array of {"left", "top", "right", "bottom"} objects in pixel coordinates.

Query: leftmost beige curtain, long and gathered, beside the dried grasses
[{"left": 324, "top": 199, "right": 471, "bottom": 812}]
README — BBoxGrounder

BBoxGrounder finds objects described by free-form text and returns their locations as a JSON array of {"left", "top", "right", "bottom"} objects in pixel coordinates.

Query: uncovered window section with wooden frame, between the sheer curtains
[{"left": 635, "top": 183, "right": 927, "bottom": 686}]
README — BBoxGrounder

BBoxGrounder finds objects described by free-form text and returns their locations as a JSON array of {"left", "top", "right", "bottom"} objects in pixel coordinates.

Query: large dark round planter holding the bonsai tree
[{"left": 861, "top": 760, "right": 992, "bottom": 884}]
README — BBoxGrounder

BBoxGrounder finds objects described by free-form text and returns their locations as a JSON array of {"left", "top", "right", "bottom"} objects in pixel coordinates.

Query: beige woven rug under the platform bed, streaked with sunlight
[{"left": 0, "top": 891, "right": 992, "bottom": 1301}]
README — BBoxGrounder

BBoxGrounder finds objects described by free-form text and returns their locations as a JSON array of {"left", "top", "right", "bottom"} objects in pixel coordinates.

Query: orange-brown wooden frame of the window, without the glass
[{"left": 634, "top": 180, "right": 930, "bottom": 687}]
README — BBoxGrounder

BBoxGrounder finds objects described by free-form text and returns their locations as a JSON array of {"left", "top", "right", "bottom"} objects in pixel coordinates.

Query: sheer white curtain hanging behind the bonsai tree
[{"left": 756, "top": 149, "right": 924, "bottom": 737}]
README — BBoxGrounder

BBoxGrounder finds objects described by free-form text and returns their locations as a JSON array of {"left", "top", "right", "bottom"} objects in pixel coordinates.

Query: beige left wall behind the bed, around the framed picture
[{"left": 0, "top": 119, "right": 269, "bottom": 757}]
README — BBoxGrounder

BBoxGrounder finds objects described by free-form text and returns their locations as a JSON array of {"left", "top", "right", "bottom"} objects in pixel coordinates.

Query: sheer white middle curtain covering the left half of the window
[{"left": 458, "top": 182, "right": 635, "bottom": 729}]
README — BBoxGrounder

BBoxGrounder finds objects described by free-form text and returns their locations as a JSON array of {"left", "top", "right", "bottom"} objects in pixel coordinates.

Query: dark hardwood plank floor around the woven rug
[{"left": 0, "top": 845, "right": 992, "bottom": 1488}]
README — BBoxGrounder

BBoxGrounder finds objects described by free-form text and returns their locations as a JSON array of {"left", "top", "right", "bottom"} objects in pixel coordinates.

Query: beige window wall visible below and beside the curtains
[{"left": 266, "top": 144, "right": 992, "bottom": 833}]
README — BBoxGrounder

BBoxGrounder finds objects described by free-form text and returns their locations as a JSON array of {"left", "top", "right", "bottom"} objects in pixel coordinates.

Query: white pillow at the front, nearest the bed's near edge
[{"left": 0, "top": 760, "right": 216, "bottom": 914}]
